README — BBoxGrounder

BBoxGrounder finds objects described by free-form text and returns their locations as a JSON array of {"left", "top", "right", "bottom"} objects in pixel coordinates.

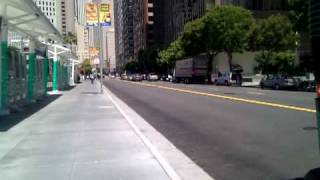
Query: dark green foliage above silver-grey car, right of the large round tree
[{"left": 251, "top": 15, "right": 298, "bottom": 74}]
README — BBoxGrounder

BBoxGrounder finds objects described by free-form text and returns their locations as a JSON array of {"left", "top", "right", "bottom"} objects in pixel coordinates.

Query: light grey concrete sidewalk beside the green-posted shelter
[{"left": 0, "top": 82, "right": 170, "bottom": 180}]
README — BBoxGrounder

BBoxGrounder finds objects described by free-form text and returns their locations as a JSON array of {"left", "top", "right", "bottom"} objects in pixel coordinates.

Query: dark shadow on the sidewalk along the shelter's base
[{"left": 0, "top": 95, "right": 61, "bottom": 132}]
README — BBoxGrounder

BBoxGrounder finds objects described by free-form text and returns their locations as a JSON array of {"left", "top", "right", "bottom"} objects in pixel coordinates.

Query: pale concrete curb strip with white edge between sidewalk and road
[{"left": 103, "top": 81, "right": 214, "bottom": 180}]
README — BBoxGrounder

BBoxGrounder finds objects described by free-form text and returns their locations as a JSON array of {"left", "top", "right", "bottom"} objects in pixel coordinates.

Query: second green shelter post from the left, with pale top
[{"left": 27, "top": 40, "right": 36, "bottom": 102}]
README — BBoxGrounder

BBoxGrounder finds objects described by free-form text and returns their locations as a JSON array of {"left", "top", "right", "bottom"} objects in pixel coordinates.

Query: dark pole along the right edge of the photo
[{"left": 310, "top": 0, "right": 320, "bottom": 150}]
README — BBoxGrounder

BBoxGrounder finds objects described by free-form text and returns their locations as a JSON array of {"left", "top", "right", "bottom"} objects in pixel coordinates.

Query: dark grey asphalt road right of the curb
[{"left": 105, "top": 80, "right": 320, "bottom": 180}]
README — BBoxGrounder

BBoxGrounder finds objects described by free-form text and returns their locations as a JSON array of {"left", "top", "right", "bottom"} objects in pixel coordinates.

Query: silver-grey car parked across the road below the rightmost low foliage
[{"left": 260, "top": 75, "right": 299, "bottom": 90}]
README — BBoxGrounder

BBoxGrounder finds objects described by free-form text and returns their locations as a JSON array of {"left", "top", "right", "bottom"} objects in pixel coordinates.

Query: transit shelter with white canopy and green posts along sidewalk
[{"left": 0, "top": 0, "right": 71, "bottom": 115}]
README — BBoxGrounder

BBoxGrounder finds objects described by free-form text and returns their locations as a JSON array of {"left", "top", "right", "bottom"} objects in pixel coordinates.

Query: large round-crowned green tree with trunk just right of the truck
[{"left": 205, "top": 6, "right": 254, "bottom": 71}]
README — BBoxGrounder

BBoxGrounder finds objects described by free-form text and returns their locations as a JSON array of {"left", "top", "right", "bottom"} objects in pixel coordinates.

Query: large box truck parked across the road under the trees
[{"left": 173, "top": 55, "right": 208, "bottom": 84}]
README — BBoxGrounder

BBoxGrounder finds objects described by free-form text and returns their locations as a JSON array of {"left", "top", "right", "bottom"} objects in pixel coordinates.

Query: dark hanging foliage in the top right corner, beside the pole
[{"left": 288, "top": 0, "right": 309, "bottom": 33}]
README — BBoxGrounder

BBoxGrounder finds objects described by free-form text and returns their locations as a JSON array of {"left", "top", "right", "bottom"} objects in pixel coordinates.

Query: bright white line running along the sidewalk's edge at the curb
[{"left": 103, "top": 83, "right": 182, "bottom": 180}]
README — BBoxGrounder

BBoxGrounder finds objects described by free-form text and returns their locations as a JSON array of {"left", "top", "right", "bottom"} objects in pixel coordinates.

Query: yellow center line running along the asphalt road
[{"left": 122, "top": 81, "right": 316, "bottom": 113}]
